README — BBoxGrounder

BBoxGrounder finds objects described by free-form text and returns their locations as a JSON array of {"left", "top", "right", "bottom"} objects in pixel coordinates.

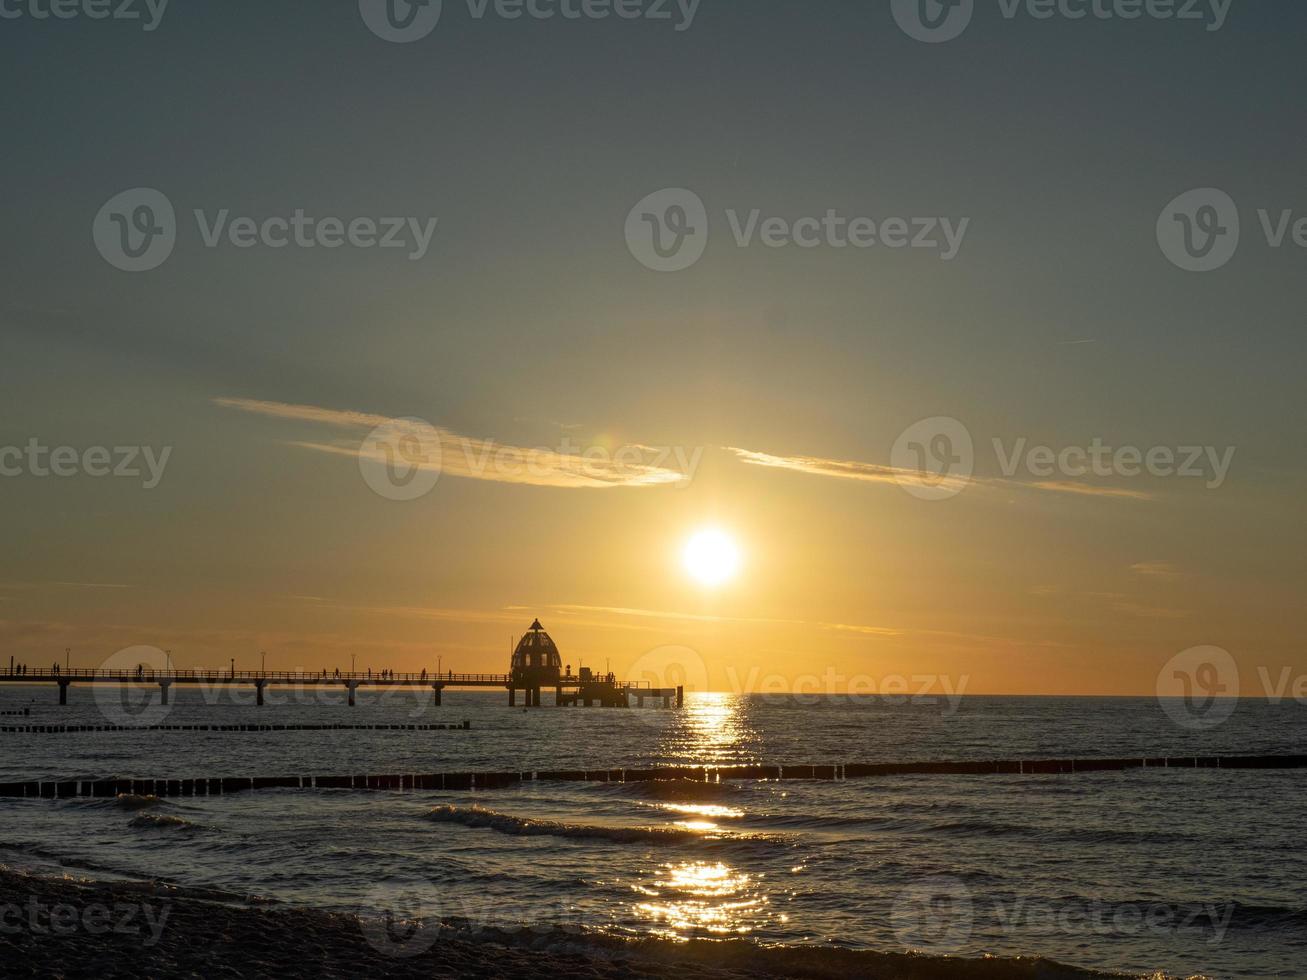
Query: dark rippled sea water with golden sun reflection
[{"left": 0, "top": 687, "right": 1307, "bottom": 977}]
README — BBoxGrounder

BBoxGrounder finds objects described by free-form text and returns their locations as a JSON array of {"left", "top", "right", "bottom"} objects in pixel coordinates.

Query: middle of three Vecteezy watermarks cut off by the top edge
[{"left": 358, "top": 0, "right": 702, "bottom": 44}]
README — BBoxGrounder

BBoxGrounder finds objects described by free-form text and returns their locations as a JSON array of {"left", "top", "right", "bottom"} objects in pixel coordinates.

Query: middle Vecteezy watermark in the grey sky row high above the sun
[{"left": 625, "top": 187, "right": 971, "bottom": 272}]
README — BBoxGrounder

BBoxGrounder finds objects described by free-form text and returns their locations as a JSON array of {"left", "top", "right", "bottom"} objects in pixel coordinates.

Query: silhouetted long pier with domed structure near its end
[{"left": 0, "top": 619, "right": 685, "bottom": 708}]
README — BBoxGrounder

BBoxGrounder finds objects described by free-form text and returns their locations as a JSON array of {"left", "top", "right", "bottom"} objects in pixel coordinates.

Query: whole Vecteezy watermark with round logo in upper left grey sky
[{"left": 91, "top": 187, "right": 439, "bottom": 272}]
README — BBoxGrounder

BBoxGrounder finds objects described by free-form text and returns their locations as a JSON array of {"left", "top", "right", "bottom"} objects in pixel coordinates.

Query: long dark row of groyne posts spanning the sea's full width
[{"left": 0, "top": 755, "right": 1307, "bottom": 800}]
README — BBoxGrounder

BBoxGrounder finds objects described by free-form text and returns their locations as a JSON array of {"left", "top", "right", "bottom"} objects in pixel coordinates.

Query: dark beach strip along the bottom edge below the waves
[{"left": 0, "top": 865, "right": 1121, "bottom": 980}]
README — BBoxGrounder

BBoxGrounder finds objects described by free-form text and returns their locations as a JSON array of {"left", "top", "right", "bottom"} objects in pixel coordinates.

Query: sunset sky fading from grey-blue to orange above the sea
[{"left": 0, "top": 0, "right": 1307, "bottom": 695}]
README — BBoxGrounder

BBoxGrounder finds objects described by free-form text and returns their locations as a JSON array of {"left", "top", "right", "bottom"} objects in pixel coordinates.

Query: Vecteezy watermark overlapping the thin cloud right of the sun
[{"left": 890, "top": 416, "right": 1236, "bottom": 500}]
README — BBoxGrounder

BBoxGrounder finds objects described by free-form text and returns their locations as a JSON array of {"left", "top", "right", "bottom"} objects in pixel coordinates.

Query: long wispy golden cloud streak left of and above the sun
[{"left": 213, "top": 397, "right": 698, "bottom": 490}]
